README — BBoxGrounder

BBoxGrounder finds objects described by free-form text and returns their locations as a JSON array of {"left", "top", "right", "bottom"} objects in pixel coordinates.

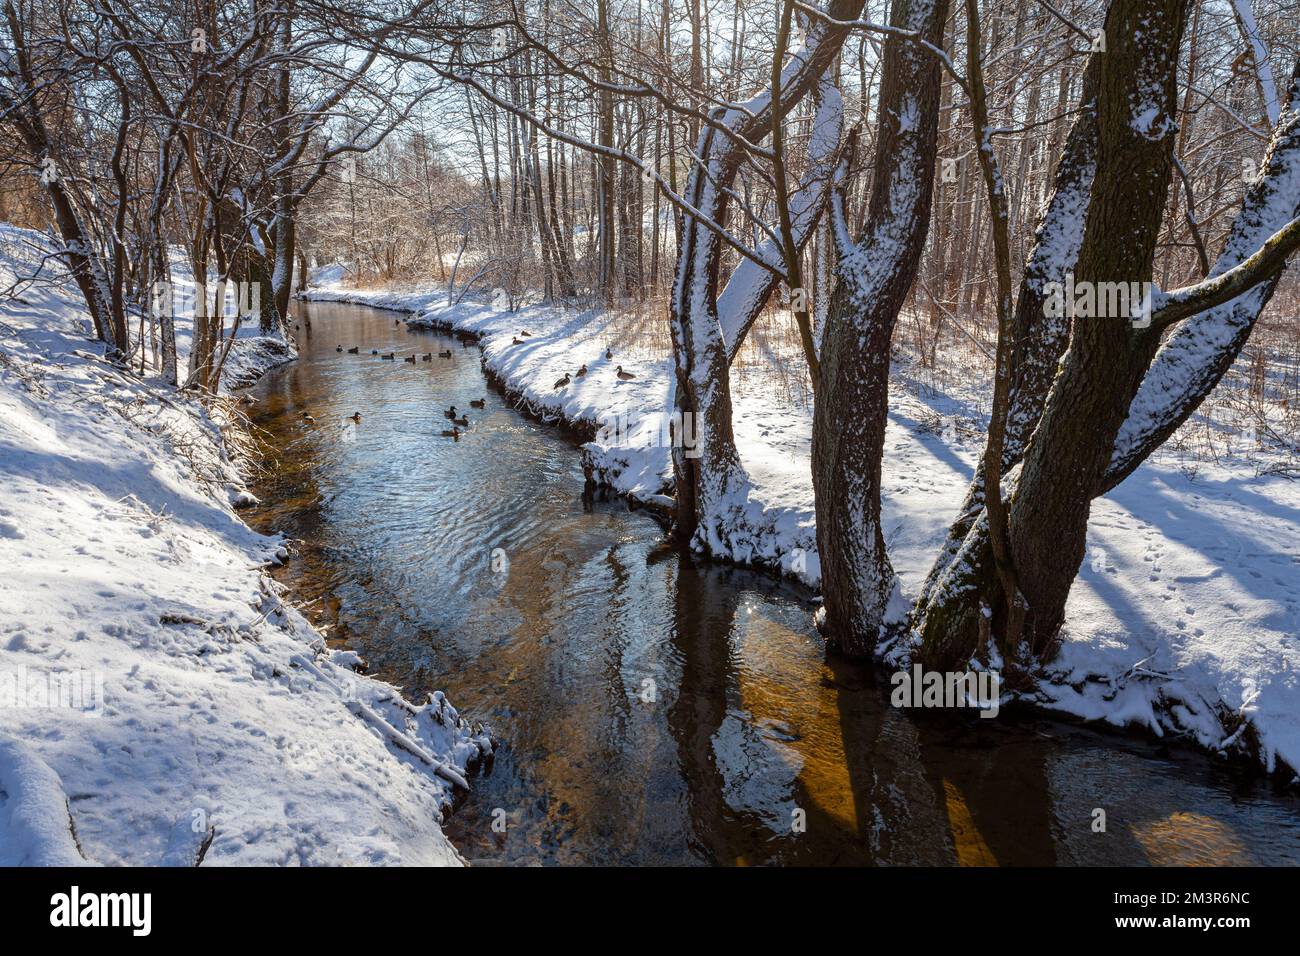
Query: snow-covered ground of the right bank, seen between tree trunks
[{"left": 306, "top": 273, "right": 1300, "bottom": 779}]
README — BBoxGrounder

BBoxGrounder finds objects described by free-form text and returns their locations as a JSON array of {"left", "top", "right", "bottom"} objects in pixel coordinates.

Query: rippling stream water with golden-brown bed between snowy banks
[{"left": 251, "top": 304, "right": 1300, "bottom": 865}]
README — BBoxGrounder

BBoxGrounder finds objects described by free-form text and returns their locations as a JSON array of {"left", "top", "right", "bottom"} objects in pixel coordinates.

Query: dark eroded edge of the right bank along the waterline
[{"left": 295, "top": 287, "right": 1300, "bottom": 793}]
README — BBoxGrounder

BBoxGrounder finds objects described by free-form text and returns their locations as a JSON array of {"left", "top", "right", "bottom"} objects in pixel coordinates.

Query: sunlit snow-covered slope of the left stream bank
[{"left": 0, "top": 226, "right": 486, "bottom": 865}]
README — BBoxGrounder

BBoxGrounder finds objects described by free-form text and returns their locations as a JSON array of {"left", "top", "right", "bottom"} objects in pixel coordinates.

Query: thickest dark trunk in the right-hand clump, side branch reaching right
[{"left": 926, "top": 0, "right": 1187, "bottom": 666}]
